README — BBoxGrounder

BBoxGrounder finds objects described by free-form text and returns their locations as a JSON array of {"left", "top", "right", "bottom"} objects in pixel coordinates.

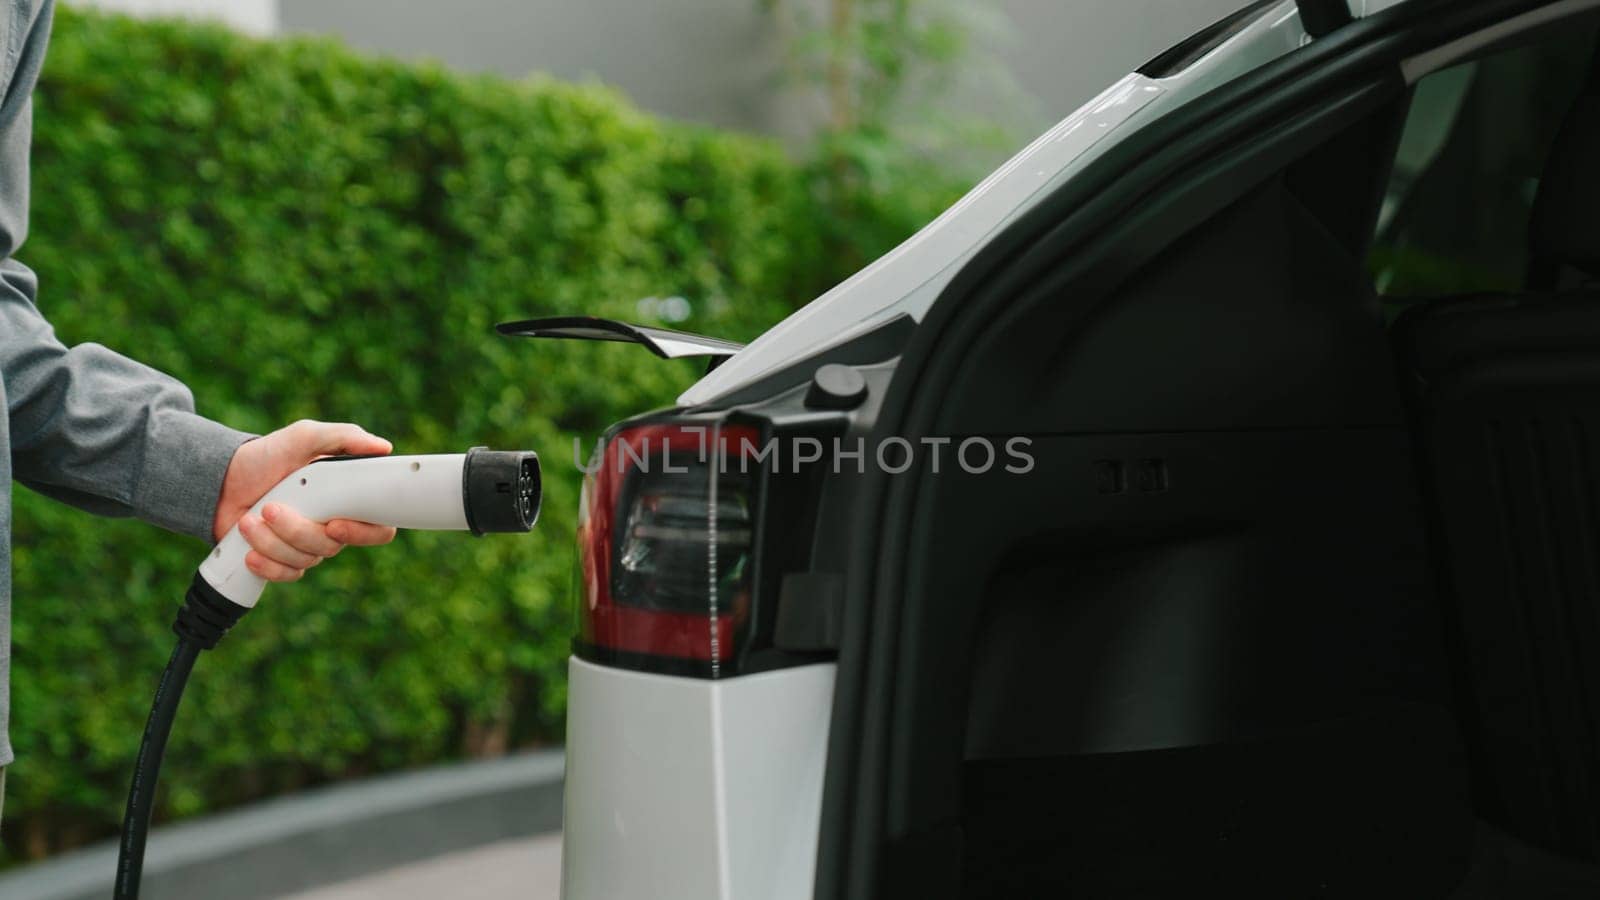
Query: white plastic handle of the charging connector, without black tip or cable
[{"left": 200, "top": 453, "right": 469, "bottom": 609}]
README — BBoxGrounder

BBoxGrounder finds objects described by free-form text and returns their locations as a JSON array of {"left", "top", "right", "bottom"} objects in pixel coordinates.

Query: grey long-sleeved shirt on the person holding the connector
[{"left": 0, "top": 0, "right": 250, "bottom": 541}]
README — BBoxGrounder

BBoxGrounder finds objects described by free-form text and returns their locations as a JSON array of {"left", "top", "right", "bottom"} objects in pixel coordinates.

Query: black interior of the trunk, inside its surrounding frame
[{"left": 883, "top": 40, "right": 1600, "bottom": 898}]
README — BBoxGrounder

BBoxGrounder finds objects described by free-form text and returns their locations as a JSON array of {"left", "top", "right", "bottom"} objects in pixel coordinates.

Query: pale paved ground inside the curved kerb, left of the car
[{"left": 282, "top": 834, "right": 562, "bottom": 900}]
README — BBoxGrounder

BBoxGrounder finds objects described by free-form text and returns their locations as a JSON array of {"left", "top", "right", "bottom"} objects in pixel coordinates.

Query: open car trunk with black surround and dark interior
[{"left": 819, "top": 3, "right": 1600, "bottom": 898}]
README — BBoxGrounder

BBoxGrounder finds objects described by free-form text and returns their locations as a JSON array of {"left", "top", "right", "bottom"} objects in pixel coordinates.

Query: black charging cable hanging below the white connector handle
[{"left": 112, "top": 573, "right": 250, "bottom": 900}]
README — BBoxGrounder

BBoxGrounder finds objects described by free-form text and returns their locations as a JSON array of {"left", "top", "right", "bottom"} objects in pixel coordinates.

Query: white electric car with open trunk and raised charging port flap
[{"left": 502, "top": 0, "right": 1600, "bottom": 900}]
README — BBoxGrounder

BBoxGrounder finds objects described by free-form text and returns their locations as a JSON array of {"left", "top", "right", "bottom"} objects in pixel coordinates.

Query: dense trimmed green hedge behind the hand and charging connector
[{"left": 5, "top": 11, "right": 947, "bottom": 858}]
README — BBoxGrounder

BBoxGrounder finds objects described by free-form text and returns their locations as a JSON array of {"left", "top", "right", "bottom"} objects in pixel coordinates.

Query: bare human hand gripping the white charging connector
[{"left": 211, "top": 420, "right": 395, "bottom": 581}]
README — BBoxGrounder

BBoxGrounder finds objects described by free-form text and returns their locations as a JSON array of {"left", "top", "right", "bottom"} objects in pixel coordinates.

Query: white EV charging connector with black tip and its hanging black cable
[{"left": 114, "top": 447, "right": 541, "bottom": 900}]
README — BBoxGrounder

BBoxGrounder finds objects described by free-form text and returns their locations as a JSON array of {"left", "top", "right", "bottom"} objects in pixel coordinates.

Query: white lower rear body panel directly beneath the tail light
[{"left": 562, "top": 658, "right": 834, "bottom": 900}]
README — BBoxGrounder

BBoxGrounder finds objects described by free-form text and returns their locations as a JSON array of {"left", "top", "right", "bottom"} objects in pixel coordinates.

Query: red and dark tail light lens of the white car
[{"left": 576, "top": 423, "right": 760, "bottom": 677}]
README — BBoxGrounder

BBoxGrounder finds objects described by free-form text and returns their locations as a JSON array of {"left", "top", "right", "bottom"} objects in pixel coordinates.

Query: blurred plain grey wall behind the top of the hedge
[{"left": 278, "top": 0, "right": 1246, "bottom": 136}]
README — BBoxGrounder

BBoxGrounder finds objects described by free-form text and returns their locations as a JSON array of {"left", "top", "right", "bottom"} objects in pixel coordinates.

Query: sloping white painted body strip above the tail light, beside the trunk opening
[{"left": 678, "top": 0, "right": 1312, "bottom": 407}]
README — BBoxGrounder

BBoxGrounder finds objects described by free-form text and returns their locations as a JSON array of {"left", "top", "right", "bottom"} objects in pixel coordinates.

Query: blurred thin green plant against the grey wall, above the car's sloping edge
[{"left": 757, "top": 0, "right": 1042, "bottom": 273}]
